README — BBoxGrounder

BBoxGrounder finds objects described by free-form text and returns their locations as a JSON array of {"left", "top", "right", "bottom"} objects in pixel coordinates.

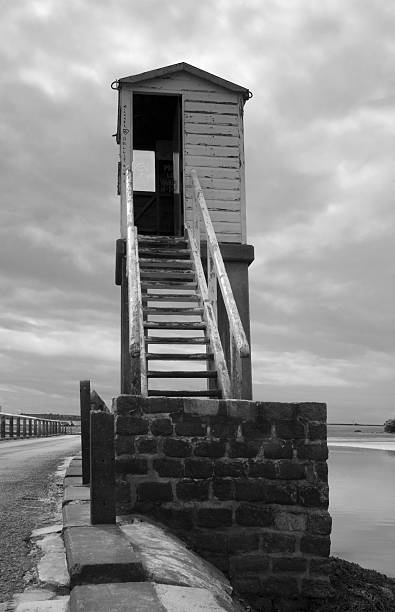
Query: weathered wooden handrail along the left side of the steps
[{"left": 125, "top": 167, "right": 148, "bottom": 395}]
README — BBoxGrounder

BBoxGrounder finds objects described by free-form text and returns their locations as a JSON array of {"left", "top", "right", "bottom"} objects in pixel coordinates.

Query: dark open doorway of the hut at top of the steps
[{"left": 133, "top": 94, "right": 183, "bottom": 236}]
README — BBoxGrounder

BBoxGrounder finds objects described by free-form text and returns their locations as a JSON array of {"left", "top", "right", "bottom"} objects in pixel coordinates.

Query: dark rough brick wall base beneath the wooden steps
[{"left": 114, "top": 395, "right": 331, "bottom": 610}]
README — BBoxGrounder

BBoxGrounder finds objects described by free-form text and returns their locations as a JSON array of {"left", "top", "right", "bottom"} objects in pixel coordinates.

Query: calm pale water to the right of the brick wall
[{"left": 328, "top": 426, "right": 395, "bottom": 577}]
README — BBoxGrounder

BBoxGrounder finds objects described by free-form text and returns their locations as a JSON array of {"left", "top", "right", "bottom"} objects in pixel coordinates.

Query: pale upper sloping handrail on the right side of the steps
[{"left": 191, "top": 170, "right": 250, "bottom": 357}]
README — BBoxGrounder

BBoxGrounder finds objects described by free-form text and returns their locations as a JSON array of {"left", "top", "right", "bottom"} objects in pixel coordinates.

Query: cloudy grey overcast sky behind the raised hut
[{"left": 0, "top": 0, "right": 395, "bottom": 422}]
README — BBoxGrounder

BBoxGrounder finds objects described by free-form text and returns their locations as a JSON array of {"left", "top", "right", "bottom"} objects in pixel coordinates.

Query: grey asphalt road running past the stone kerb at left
[{"left": 0, "top": 436, "right": 80, "bottom": 602}]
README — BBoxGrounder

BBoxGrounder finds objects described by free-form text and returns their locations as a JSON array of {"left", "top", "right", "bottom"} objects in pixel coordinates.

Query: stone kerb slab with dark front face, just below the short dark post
[{"left": 64, "top": 525, "right": 145, "bottom": 588}]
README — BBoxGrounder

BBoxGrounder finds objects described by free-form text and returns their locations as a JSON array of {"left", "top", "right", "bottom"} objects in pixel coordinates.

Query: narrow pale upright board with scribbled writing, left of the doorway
[{"left": 119, "top": 87, "right": 133, "bottom": 238}]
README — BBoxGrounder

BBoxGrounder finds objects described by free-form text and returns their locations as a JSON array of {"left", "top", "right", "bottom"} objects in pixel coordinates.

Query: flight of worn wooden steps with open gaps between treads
[{"left": 138, "top": 235, "right": 222, "bottom": 398}]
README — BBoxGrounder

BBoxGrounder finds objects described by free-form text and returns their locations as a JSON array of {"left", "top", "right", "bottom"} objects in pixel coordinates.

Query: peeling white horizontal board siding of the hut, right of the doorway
[{"left": 125, "top": 72, "right": 246, "bottom": 243}]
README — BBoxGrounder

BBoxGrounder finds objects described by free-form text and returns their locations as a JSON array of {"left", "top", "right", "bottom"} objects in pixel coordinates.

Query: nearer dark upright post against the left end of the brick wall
[{"left": 90, "top": 410, "right": 115, "bottom": 525}]
